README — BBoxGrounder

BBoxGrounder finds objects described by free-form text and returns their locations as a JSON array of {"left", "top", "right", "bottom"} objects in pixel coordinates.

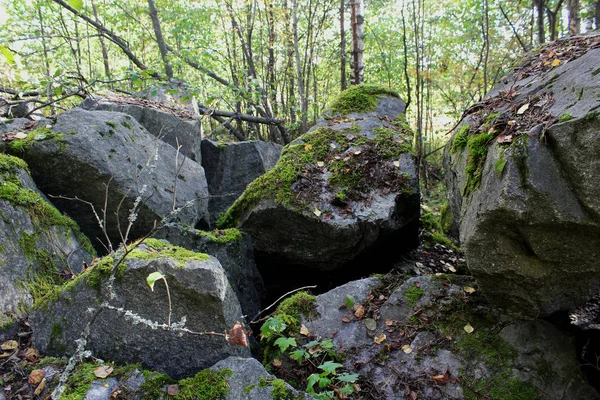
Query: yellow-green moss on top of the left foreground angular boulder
[{"left": 127, "top": 238, "right": 210, "bottom": 268}]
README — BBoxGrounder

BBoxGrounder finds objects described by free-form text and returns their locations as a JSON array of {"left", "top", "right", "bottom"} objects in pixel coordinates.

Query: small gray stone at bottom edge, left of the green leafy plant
[{"left": 210, "top": 357, "right": 312, "bottom": 400}]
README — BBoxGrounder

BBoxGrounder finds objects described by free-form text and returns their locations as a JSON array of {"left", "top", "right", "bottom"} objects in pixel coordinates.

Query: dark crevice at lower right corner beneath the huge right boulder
[{"left": 546, "top": 311, "right": 600, "bottom": 391}]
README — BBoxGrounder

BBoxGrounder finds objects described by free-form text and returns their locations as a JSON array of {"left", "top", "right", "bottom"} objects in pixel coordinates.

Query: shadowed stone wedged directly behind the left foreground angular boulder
[{"left": 153, "top": 224, "right": 264, "bottom": 320}]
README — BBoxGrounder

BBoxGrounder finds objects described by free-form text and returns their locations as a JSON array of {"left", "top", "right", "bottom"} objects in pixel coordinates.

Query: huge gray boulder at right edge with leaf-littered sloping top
[{"left": 445, "top": 32, "right": 600, "bottom": 318}]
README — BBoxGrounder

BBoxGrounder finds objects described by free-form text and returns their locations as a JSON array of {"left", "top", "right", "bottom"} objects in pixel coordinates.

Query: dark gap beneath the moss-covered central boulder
[{"left": 255, "top": 220, "right": 419, "bottom": 316}]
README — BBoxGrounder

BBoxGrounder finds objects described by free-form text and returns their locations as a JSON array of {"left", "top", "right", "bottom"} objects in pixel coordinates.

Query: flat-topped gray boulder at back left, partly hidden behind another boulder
[{"left": 80, "top": 95, "right": 202, "bottom": 164}]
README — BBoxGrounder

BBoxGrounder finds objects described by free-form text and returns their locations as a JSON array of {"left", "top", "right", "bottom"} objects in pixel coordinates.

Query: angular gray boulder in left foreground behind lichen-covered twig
[{"left": 29, "top": 239, "right": 250, "bottom": 379}]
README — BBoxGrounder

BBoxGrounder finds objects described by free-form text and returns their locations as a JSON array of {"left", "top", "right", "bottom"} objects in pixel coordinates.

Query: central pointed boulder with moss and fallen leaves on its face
[{"left": 220, "top": 86, "right": 419, "bottom": 272}]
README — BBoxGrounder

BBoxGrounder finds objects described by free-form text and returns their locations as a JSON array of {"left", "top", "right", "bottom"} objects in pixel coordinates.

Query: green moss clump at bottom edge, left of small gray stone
[{"left": 174, "top": 369, "right": 232, "bottom": 400}]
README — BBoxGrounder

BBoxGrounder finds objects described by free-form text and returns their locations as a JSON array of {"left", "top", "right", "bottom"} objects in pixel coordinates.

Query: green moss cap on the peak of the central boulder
[{"left": 327, "top": 85, "right": 400, "bottom": 115}]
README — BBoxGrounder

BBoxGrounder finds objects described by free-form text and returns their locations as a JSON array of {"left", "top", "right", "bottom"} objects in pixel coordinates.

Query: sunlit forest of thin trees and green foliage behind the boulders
[{"left": 0, "top": 0, "right": 600, "bottom": 155}]
